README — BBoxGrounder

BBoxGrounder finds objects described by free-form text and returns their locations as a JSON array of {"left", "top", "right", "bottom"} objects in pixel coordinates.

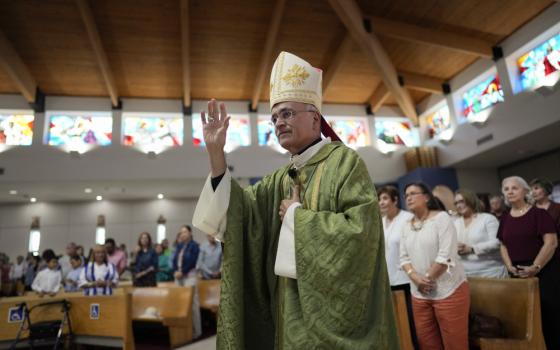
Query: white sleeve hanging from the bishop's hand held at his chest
[{"left": 274, "top": 202, "right": 301, "bottom": 279}]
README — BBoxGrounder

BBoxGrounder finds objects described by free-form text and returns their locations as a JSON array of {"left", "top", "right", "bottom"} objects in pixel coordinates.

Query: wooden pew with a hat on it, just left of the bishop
[{"left": 132, "top": 287, "right": 193, "bottom": 348}]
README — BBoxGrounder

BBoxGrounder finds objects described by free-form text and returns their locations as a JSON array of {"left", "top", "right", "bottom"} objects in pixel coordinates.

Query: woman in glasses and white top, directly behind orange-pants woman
[{"left": 455, "top": 190, "right": 507, "bottom": 278}]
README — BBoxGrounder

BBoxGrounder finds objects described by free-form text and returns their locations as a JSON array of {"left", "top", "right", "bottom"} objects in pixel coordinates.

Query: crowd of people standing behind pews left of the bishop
[{"left": 0, "top": 225, "right": 222, "bottom": 297}]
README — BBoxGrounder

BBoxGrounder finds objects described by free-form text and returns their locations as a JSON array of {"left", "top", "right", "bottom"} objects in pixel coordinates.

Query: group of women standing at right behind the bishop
[{"left": 378, "top": 176, "right": 560, "bottom": 349}]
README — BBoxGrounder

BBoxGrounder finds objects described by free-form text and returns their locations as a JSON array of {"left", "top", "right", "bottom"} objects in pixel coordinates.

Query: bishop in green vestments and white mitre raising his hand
[{"left": 193, "top": 52, "right": 399, "bottom": 350}]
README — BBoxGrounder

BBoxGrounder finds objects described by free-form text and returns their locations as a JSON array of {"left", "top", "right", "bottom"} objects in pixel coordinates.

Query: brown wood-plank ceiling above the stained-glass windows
[{"left": 0, "top": 0, "right": 554, "bottom": 115}]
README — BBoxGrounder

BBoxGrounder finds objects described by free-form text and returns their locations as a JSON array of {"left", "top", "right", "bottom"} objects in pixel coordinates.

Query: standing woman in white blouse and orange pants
[{"left": 400, "top": 183, "right": 470, "bottom": 350}]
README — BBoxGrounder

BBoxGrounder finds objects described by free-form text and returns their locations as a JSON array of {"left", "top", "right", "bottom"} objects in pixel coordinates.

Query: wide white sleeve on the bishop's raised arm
[{"left": 193, "top": 169, "right": 231, "bottom": 241}]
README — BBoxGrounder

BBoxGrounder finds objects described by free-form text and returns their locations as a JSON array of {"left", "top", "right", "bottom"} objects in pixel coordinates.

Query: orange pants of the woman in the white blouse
[{"left": 412, "top": 282, "right": 471, "bottom": 350}]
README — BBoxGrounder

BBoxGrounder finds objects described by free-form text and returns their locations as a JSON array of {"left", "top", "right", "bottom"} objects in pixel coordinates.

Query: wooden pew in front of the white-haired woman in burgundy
[{"left": 469, "top": 278, "right": 544, "bottom": 350}]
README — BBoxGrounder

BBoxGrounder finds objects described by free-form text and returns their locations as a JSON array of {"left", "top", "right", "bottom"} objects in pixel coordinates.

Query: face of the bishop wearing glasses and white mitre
[{"left": 271, "top": 102, "right": 321, "bottom": 154}]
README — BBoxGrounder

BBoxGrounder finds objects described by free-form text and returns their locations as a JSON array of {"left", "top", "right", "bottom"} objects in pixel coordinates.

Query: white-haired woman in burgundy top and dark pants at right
[{"left": 498, "top": 176, "right": 560, "bottom": 349}]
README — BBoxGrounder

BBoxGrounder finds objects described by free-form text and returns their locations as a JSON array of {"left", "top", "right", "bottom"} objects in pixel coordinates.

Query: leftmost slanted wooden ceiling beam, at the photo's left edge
[{"left": 0, "top": 30, "right": 37, "bottom": 103}]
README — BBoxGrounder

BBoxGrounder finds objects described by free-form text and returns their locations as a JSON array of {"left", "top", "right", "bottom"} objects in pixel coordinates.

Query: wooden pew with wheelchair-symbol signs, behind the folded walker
[{"left": 0, "top": 293, "right": 134, "bottom": 350}]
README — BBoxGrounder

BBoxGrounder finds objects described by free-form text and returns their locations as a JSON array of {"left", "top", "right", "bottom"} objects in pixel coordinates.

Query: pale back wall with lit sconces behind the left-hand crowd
[{"left": 0, "top": 199, "right": 204, "bottom": 259}]
